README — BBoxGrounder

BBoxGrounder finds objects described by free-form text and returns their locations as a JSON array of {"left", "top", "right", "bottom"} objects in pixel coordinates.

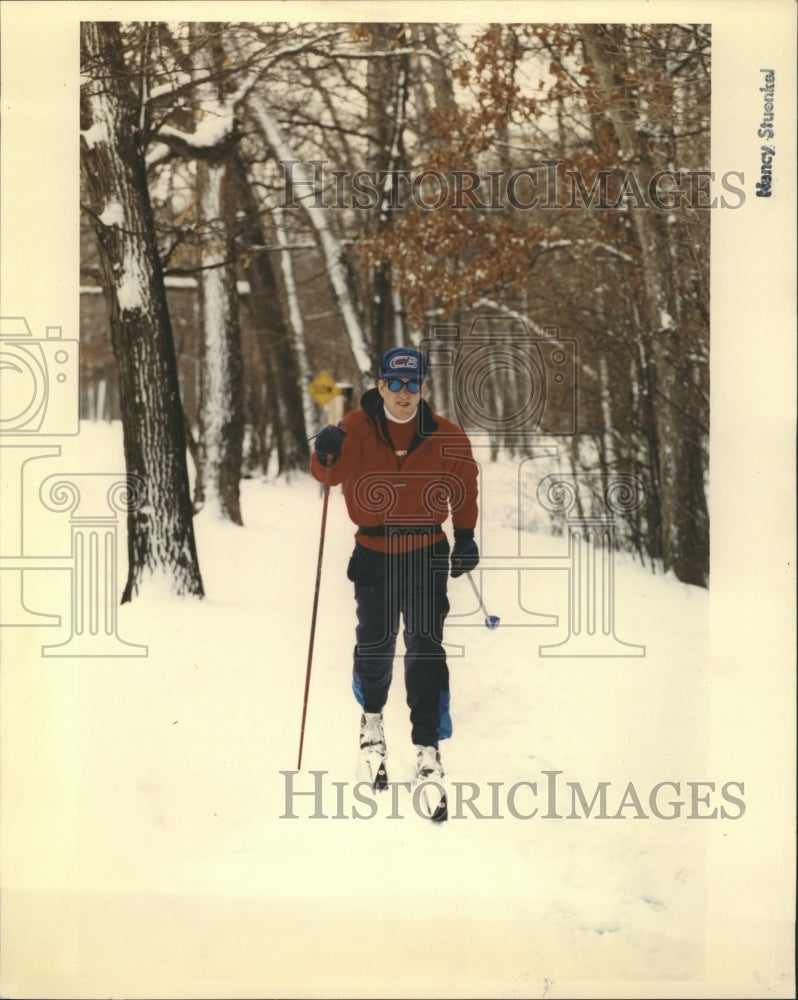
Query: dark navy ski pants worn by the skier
[{"left": 347, "top": 538, "right": 452, "bottom": 747}]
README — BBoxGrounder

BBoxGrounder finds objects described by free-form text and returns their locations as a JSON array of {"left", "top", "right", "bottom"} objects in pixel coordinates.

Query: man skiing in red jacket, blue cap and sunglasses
[{"left": 311, "top": 347, "right": 479, "bottom": 819}]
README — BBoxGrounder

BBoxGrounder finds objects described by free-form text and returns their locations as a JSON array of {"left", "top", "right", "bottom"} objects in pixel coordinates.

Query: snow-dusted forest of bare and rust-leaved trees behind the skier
[{"left": 80, "top": 21, "right": 712, "bottom": 601}]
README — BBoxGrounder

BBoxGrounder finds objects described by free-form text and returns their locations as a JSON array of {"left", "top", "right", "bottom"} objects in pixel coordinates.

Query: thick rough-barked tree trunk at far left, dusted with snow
[{"left": 81, "top": 21, "right": 203, "bottom": 603}]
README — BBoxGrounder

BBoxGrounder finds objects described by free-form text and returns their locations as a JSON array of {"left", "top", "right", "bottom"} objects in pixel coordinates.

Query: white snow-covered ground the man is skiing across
[{"left": 6, "top": 428, "right": 768, "bottom": 997}]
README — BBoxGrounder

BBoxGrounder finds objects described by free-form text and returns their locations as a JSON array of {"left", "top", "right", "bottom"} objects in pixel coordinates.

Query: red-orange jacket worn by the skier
[{"left": 311, "top": 389, "right": 479, "bottom": 549}]
